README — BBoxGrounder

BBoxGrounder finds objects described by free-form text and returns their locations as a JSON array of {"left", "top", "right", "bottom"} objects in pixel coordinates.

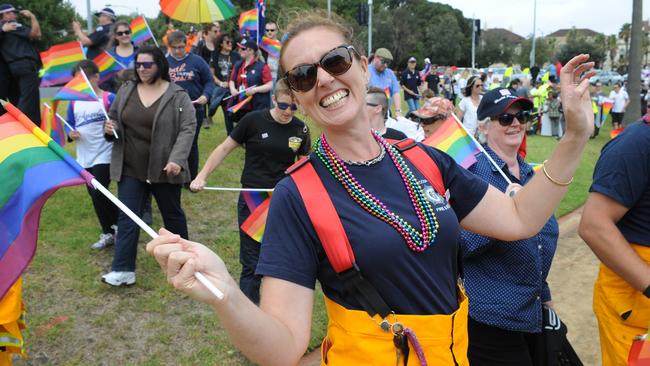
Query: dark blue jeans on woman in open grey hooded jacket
[{"left": 111, "top": 176, "right": 187, "bottom": 272}]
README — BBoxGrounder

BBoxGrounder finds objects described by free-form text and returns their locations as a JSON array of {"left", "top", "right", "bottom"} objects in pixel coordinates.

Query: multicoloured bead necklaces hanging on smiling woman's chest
[{"left": 314, "top": 131, "right": 439, "bottom": 252}]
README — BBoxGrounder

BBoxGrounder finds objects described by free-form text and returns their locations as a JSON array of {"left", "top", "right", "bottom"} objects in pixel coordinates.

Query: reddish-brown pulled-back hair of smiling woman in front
[{"left": 278, "top": 10, "right": 364, "bottom": 75}]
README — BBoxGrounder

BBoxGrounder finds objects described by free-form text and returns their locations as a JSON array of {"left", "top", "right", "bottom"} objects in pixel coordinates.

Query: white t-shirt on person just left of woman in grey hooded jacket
[{"left": 68, "top": 98, "right": 113, "bottom": 168}]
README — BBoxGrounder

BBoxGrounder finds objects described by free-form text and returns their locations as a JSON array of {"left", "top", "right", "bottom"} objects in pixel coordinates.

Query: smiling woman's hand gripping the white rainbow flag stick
[{"left": 147, "top": 228, "right": 238, "bottom": 304}]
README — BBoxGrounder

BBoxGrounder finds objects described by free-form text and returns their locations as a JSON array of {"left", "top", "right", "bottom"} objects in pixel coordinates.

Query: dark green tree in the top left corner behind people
[{"left": 11, "top": 0, "right": 76, "bottom": 51}]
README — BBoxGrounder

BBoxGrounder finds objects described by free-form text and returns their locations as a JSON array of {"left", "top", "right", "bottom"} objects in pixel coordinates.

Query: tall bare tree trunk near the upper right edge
[{"left": 624, "top": 0, "right": 643, "bottom": 126}]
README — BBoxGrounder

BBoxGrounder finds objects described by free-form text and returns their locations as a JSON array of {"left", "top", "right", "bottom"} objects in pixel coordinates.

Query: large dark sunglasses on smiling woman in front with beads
[{"left": 284, "top": 45, "right": 357, "bottom": 92}]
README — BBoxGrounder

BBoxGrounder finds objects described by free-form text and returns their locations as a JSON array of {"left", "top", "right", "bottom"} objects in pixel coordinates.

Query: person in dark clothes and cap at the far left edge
[{"left": 0, "top": 4, "right": 41, "bottom": 124}]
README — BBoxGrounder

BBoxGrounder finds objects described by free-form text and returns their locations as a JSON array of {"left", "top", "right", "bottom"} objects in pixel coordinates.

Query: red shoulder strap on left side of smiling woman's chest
[{"left": 288, "top": 158, "right": 355, "bottom": 273}]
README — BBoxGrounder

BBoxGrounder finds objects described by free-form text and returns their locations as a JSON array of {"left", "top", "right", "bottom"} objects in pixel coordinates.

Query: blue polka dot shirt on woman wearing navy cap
[{"left": 460, "top": 146, "right": 558, "bottom": 333}]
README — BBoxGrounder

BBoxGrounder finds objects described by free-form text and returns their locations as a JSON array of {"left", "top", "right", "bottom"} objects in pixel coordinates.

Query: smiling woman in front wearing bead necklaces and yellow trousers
[{"left": 147, "top": 11, "right": 593, "bottom": 365}]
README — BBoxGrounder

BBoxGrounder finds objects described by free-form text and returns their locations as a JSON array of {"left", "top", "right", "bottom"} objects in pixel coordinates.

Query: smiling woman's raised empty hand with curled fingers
[{"left": 560, "top": 54, "right": 596, "bottom": 138}]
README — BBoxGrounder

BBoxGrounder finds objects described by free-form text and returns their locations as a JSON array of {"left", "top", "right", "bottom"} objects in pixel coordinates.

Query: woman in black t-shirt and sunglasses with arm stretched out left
[{"left": 190, "top": 80, "right": 311, "bottom": 304}]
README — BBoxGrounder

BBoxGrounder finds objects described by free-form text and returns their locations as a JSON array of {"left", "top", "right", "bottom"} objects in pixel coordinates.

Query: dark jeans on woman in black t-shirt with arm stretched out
[{"left": 237, "top": 194, "right": 262, "bottom": 304}]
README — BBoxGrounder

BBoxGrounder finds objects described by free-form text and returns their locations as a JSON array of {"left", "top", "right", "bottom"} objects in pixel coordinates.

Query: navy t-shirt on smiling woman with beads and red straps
[{"left": 257, "top": 145, "right": 488, "bottom": 314}]
